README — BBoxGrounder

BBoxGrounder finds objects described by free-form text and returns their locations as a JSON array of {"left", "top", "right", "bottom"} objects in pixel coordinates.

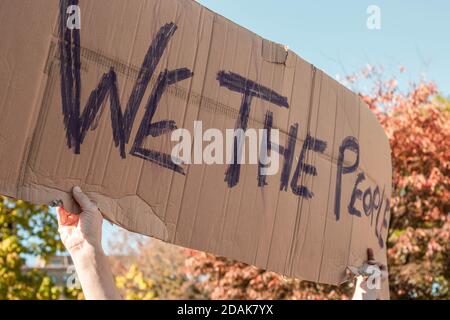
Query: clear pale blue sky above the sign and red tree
[{"left": 198, "top": 0, "right": 450, "bottom": 96}]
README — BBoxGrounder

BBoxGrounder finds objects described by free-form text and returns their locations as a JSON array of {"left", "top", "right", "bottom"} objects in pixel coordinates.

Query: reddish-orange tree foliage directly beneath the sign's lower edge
[{"left": 184, "top": 251, "right": 352, "bottom": 300}]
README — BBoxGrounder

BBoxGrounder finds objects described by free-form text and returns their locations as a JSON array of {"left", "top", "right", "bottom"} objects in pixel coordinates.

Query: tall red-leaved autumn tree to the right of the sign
[{"left": 361, "top": 69, "right": 450, "bottom": 299}]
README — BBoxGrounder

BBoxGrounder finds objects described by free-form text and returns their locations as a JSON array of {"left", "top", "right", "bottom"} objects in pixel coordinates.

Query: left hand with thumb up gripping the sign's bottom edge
[{"left": 57, "top": 187, "right": 103, "bottom": 254}]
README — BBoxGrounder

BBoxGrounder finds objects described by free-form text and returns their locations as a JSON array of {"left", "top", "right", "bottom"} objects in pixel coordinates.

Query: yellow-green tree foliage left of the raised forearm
[{"left": 0, "top": 196, "right": 62, "bottom": 300}]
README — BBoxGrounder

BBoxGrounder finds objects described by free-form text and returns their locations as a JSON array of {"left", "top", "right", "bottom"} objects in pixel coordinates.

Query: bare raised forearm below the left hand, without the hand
[{"left": 71, "top": 243, "right": 121, "bottom": 300}]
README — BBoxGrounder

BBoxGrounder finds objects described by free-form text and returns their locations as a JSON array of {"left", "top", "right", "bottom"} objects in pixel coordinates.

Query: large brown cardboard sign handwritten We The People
[{"left": 0, "top": 0, "right": 391, "bottom": 296}]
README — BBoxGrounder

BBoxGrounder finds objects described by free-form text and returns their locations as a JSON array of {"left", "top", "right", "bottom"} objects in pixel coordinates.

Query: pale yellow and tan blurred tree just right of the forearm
[{"left": 110, "top": 231, "right": 203, "bottom": 300}]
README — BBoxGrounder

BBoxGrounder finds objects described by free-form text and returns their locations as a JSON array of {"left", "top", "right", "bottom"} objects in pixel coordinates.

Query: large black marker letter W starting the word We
[{"left": 59, "top": 0, "right": 177, "bottom": 158}]
